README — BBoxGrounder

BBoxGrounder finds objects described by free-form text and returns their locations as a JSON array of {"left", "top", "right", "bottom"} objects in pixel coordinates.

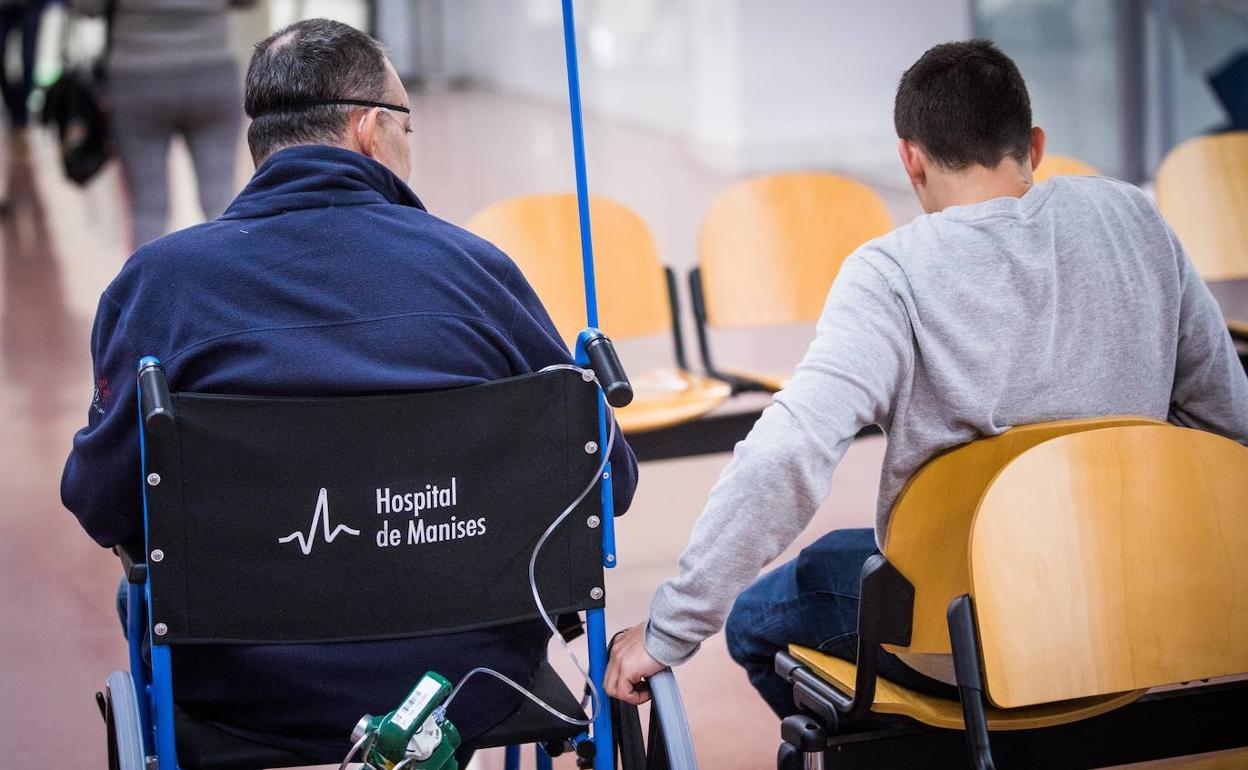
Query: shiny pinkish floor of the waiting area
[{"left": 0, "top": 85, "right": 1233, "bottom": 770}]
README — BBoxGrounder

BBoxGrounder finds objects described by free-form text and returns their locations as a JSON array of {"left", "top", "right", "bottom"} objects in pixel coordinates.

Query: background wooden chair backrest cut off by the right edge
[{"left": 1157, "top": 131, "right": 1248, "bottom": 281}]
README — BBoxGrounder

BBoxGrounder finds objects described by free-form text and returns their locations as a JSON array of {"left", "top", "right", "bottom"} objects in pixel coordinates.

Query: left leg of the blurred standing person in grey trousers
[{"left": 109, "top": 72, "right": 177, "bottom": 248}]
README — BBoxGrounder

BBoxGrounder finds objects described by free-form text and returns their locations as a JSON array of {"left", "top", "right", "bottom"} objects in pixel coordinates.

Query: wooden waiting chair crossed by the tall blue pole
[{"left": 468, "top": 193, "right": 731, "bottom": 433}]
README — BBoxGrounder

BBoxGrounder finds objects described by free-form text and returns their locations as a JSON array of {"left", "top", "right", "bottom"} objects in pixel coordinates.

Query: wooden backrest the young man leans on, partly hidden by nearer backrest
[{"left": 884, "top": 417, "right": 1164, "bottom": 654}]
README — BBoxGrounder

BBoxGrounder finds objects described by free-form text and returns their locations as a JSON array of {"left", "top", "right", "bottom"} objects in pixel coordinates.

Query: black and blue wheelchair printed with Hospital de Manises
[{"left": 96, "top": 331, "right": 696, "bottom": 770}]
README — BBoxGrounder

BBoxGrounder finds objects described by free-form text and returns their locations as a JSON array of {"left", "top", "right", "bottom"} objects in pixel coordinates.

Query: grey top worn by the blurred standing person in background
[{"left": 70, "top": 0, "right": 256, "bottom": 76}]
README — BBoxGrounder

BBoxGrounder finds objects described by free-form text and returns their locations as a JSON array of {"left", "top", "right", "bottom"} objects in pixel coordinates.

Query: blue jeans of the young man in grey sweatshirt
[{"left": 724, "top": 529, "right": 957, "bottom": 719}]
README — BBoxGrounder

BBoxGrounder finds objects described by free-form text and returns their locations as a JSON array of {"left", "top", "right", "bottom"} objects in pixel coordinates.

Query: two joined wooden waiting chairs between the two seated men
[{"left": 468, "top": 172, "right": 892, "bottom": 433}]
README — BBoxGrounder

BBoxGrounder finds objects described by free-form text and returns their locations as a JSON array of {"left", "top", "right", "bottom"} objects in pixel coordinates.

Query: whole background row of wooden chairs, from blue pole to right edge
[{"left": 467, "top": 132, "right": 1248, "bottom": 433}]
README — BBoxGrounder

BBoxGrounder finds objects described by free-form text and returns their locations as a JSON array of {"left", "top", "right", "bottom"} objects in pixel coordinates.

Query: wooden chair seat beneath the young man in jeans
[{"left": 789, "top": 644, "right": 1144, "bottom": 730}]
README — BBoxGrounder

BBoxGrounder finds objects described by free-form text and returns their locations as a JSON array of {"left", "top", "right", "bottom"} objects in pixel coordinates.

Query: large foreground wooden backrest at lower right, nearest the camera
[{"left": 970, "top": 426, "right": 1248, "bottom": 708}]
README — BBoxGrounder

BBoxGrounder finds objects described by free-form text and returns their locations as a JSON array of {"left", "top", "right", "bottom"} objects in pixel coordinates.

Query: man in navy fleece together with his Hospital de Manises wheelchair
[{"left": 62, "top": 20, "right": 693, "bottom": 770}]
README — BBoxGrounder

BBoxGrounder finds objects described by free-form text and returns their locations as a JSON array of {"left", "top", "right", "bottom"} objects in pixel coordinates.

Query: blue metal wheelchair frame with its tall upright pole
[{"left": 126, "top": 0, "right": 633, "bottom": 770}]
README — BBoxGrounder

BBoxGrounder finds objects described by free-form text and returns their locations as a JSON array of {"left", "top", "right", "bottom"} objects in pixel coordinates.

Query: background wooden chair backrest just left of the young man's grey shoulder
[{"left": 699, "top": 172, "right": 892, "bottom": 327}]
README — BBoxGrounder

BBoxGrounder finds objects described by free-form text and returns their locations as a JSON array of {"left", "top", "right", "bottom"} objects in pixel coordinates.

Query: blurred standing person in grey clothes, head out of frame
[{"left": 69, "top": 0, "right": 255, "bottom": 247}]
